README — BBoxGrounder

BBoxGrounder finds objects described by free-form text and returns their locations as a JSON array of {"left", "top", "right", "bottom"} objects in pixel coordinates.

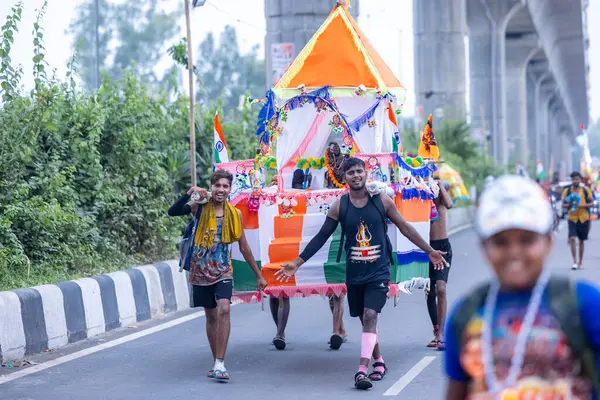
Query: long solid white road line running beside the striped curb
[{"left": 0, "top": 311, "right": 204, "bottom": 385}]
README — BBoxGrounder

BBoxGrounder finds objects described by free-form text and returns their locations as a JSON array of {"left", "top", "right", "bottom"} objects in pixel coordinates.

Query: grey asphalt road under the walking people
[{"left": 0, "top": 226, "right": 600, "bottom": 400}]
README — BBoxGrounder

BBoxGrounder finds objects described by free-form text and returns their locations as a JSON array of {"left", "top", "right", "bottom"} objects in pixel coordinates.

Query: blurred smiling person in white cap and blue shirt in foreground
[{"left": 445, "top": 175, "right": 600, "bottom": 400}]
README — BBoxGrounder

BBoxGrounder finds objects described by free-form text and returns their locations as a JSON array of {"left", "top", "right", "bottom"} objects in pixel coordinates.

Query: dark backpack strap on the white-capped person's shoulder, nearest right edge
[{"left": 546, "top": 276, "right": 600, "bottom": 398}]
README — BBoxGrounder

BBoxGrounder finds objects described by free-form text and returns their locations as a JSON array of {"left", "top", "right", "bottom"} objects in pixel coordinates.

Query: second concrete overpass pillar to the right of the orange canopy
[{"left": 467, "top": 0, "right": 524, "bottom": 167}]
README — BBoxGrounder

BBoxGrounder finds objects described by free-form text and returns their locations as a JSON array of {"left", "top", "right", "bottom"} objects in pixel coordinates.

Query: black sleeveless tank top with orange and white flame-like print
[{"left": 344, "top": 199, "right": 390, "bottom": 285}]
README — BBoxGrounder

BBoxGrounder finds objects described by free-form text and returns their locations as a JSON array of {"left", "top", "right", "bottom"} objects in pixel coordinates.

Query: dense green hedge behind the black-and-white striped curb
[{"left": 0, "top": 6, "right": 256, "bottom": 290}]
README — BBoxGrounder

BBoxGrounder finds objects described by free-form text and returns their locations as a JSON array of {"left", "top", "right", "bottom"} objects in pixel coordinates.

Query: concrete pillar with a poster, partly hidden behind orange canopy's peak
[{"left": 265, "top": 0, "right": 359, "bottom": 87}]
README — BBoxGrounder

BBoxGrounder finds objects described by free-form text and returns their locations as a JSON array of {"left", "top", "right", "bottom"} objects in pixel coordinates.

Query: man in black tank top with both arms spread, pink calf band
[{"left": 276, "top": 158, "right": 445, "bottom": 390}]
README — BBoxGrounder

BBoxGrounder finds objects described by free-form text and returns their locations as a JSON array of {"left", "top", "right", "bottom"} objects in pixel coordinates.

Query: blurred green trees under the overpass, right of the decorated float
[{"left": 401, "top": 121, "right": 502, "bottom": 193}]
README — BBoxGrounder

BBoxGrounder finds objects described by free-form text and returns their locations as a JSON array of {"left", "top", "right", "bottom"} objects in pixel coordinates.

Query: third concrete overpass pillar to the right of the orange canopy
[{"left": 502, "top": 34, "right": 540, "bottom": 165}]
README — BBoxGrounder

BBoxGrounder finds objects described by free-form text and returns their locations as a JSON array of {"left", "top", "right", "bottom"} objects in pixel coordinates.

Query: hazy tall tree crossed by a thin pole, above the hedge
[{"left": 69, "top": 0, "right": 181, "bottom": 89}]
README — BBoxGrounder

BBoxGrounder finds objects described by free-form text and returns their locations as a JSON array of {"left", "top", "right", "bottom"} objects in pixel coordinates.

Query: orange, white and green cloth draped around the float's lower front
[{"left": 232, "top": 196, "right": 431, "bottom": 302}]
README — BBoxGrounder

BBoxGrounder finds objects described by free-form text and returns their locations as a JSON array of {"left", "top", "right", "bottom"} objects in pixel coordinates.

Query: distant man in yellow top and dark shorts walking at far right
[{"left": 562, "top": 172, "right": 593, "bottom": 270}]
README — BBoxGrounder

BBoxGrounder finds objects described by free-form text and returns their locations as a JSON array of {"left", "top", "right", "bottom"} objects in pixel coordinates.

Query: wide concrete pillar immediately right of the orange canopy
[{"left": 413, "top": 0, "right": 466, "bottom": 119}]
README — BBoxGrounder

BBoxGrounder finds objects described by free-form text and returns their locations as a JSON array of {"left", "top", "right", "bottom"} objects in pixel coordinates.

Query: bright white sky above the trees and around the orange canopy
[{"left": 0, "top": 0, "right": 600, "bottom": 120}]
